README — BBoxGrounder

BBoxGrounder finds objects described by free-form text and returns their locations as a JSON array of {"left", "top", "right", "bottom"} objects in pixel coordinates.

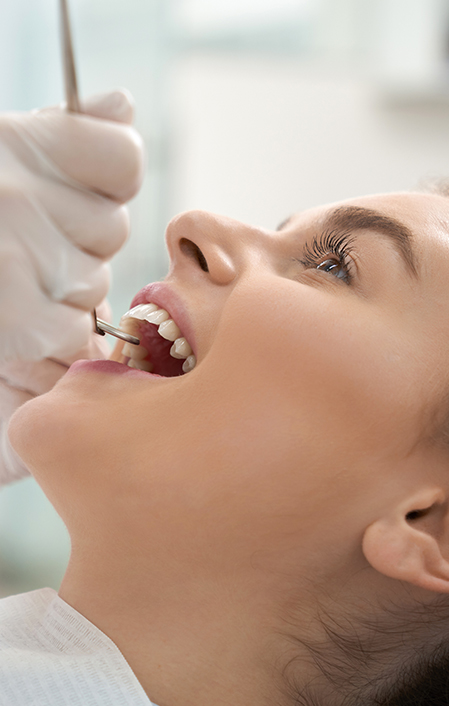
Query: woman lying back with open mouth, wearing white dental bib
[{"left": 0, "top": 91, "right": 449, "bottom": 706}]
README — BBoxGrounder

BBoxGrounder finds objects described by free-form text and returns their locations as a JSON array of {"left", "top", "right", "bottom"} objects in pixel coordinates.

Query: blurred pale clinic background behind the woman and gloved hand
[{"left": 0, "top": 0, "right": 449, "bottom": 596}]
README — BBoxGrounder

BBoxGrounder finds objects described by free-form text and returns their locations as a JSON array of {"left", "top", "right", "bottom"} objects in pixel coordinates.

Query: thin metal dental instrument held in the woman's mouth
[{"left": 59, "top": 0, "right": 140, "bottom": 346}]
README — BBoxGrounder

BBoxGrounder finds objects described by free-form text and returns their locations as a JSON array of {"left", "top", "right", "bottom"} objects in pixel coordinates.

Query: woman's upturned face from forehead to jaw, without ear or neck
[{"left": 11, "top": 194, "right": 449, "bottom": 570}]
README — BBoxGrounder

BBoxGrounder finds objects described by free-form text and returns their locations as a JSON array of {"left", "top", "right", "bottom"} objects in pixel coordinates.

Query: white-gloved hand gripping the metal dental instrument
[{"left": 0, "top": 91, "right": 143, "bottom": 362}]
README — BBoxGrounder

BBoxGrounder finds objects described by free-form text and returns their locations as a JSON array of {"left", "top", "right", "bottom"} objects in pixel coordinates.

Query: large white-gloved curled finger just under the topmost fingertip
[{"left": 15, "top": 107, "right": 144, "bottom": 203}]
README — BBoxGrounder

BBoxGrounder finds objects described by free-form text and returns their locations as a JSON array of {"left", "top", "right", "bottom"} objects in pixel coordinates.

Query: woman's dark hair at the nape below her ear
[{"left": 283, "top": 595, "right": 449, "bottom": 706}]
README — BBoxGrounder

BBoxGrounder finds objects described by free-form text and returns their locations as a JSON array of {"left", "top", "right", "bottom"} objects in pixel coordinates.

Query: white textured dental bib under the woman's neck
[{"left": 0, "top": 588, "right": 155, "bottom": 706}]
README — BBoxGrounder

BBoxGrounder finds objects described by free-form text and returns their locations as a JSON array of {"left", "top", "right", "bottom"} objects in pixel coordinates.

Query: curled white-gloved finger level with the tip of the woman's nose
[{"left": 33, "top": 178, "right": 130, "bottom": 259}]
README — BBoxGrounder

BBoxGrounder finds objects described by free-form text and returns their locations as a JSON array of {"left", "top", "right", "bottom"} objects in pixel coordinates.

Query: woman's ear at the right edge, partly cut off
[{"left": 362, "top": 487, "right": 449, "bottom": 593}]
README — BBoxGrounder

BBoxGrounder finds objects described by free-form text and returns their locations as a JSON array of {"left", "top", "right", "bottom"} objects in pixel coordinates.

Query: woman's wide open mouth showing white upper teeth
[{"left": 120, "top": 303, "right": 196, "bottom": 377}]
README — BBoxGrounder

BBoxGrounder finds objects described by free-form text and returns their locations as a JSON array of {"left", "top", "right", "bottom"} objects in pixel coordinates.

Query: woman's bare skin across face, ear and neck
[{"left": 10, "top": 193, "right": 449, "bottom": 706}]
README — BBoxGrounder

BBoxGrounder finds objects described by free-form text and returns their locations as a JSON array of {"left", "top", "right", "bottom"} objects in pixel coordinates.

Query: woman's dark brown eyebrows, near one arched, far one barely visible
[{"left": 277, "top": 206, "right": 418, "bottom": 277}]
